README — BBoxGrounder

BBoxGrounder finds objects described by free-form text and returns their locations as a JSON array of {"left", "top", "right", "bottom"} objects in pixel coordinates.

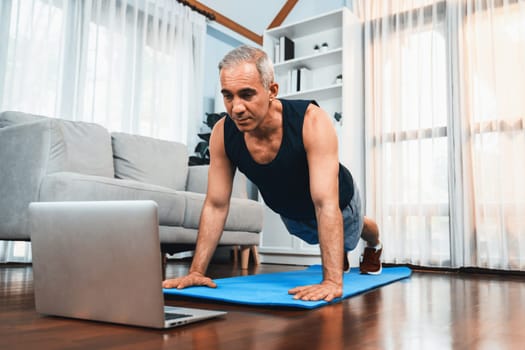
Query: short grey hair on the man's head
[{"left": 219, "top": 45, "right": 273, "bottom": 89}]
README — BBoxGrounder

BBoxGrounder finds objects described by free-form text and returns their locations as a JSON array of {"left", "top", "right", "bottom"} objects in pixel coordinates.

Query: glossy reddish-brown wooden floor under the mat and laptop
[{"left": 0, "top": 261, "right": 525, "bottom": 350}]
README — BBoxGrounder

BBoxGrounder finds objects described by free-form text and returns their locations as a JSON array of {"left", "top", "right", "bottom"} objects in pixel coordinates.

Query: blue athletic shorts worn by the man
[{"left": 281, "top": 182, "right": 364, "bottom": 252}]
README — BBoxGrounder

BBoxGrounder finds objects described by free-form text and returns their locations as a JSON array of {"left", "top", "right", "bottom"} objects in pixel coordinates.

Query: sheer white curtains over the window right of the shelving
[{"left": 353, "top": 0, "right": 525, "bottom": 270}]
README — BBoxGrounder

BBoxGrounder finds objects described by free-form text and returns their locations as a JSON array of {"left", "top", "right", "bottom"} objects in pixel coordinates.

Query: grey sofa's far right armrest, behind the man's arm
[{"left": 186, "top": 165, "right": 252, "bottom": 199}]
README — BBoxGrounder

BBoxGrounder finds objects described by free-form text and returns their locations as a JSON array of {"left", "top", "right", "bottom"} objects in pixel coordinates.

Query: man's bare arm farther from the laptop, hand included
[{"left": 289, "top": 104, "right": 344, "bottom": 301}]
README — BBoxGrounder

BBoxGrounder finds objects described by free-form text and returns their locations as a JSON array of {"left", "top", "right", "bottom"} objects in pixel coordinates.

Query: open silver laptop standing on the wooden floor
[{"left": 29, "top": 200, "right": 225, "bottom": 328}]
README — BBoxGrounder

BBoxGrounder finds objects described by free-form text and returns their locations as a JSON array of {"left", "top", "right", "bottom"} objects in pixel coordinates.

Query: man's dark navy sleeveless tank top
[{"left": 224, "top": 99, "right": 354, "bottom": 220}]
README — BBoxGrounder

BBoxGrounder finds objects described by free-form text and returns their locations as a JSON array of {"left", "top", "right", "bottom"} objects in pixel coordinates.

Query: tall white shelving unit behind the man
[{"left": 260, "top": 7, "right": 364, "bottom": 265}]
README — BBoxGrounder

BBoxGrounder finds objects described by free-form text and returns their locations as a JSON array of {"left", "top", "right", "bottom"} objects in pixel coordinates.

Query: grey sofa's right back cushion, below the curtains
[{"left": 111, "top": 132, "right": 188, "bottom": 191}]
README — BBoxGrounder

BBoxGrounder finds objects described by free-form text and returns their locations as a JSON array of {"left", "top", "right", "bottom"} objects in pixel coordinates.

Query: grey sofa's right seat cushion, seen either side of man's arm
[{"left": 183, "top": 192, "right": 264, "bottom": 232}]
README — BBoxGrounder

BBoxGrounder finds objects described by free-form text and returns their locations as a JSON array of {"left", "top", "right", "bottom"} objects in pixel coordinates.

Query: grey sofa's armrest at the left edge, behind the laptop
[{"left": 0, "top": 121, "right": 50, "bottom": 240}]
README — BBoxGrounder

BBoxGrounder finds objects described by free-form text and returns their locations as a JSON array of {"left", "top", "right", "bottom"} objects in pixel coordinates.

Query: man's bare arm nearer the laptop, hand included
[{"left": 162, "top": 119, "right": 235, "bottom": 288}]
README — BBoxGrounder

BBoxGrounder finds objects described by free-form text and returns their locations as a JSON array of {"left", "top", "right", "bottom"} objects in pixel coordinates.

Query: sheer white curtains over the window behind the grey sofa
[{"left": 0, "top": 0, "right": 206, "bottom": 261}]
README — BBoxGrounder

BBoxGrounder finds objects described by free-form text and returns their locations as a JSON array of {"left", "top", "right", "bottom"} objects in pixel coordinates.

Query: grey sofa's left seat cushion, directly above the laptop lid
[{"left": 38, "top": 173, "right": 186, "bottom": 226}]
